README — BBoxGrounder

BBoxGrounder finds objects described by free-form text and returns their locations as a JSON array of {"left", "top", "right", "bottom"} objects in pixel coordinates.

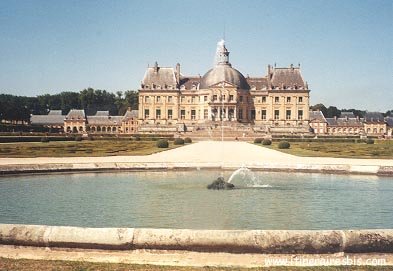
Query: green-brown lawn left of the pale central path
[{"left": 0, "top": 140, "right": 178, "bottom": 158}]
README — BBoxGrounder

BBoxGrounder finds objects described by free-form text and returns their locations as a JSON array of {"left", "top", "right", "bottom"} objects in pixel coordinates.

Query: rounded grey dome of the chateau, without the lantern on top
[{"left": 199, "top": 64, "right": 250, "bottom": 89}]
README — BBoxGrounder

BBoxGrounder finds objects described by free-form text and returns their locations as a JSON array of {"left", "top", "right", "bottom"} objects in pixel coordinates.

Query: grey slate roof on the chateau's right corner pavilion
[{"left": 271, "top": 67, "right": 305, "bottom": 88}]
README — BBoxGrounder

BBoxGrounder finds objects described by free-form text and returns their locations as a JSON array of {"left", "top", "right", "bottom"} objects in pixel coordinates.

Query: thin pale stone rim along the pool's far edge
[{"left": 0, "top": 162, "right": 393, "bottom": 176}]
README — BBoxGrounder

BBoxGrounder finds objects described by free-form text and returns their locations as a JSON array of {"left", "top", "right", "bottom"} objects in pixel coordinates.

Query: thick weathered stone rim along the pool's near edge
[{"left": 0, "top": 224, "right": 393, "bottom": 254}]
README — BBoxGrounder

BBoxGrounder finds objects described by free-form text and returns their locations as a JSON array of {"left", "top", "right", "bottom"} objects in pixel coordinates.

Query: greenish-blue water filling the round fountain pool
[{"left": 0, "top": 170, "right": 393, "bottom": 230}]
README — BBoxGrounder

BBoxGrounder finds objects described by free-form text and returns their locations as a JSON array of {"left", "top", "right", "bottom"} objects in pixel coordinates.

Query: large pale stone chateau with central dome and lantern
[{"left": 138, "top": 40, "right": 310, "bottom": 133}]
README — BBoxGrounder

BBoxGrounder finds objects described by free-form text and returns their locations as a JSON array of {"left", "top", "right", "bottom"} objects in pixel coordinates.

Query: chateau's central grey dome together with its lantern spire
[{"left": 199, "top": 40, "right": 250, "bottom": 89}]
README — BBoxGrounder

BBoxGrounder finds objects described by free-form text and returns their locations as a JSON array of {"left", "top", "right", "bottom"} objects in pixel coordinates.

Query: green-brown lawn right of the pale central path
[{"left": 267, "top": 140, "right": 393, "bottom": 159}]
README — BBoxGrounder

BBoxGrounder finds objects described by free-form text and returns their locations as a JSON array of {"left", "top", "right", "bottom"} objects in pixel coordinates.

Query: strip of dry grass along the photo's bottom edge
[{"left": 0, "top": 258, "right": 392, "bottom": 271}]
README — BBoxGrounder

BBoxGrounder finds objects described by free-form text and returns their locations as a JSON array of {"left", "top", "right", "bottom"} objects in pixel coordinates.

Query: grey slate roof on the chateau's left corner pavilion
[{"left": 142, "top": 63, "right": 177, "bottom": 89}]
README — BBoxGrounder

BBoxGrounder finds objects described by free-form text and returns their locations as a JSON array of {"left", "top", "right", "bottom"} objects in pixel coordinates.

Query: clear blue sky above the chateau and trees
[{"left": 0, "top": 0, "right": 393, "bottom": 111}]
